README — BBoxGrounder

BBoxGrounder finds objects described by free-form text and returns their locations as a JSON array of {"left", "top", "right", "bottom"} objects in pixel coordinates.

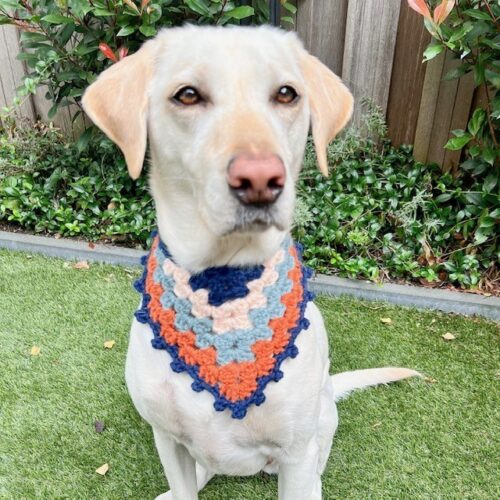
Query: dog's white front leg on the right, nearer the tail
[{"left": 278, "top": 437, "right": 321, "bottom": 500}]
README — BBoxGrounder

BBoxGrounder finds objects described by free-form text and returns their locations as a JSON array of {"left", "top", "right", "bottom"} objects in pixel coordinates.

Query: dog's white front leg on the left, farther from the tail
[{"left": 153, "top": 429, "right": 198, "bottom": 500}]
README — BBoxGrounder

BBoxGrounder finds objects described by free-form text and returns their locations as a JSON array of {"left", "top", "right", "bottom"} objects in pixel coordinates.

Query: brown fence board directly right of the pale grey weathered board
[{"left": 387, "top": 1, "right": 431, "bottom": 145}]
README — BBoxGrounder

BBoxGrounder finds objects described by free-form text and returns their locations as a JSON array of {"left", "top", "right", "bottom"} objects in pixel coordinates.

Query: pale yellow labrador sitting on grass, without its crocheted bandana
[{"left": 83, "top": 26, "right": 418, "bottom": 500}]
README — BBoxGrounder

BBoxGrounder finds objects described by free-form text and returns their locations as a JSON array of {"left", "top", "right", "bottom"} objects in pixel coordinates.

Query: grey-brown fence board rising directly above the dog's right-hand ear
[{"left": 297, "top": 0, "right": 347, "bottom": 75}]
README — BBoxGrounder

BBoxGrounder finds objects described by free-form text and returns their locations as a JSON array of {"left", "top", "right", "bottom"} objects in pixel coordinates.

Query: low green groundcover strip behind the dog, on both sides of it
[{"left": 0, "top": 107, "right": 500, "bottom": 289}]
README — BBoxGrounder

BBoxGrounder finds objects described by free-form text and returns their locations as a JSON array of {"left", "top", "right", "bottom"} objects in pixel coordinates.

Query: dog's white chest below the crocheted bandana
[{"left": 126, "top": 310, "right": 325, "bottom": 475}]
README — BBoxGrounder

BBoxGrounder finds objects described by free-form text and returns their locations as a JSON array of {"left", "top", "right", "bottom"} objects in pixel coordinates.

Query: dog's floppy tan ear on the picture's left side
[{"left": 82, "top": 42, "right": 153, "bottom": 179}]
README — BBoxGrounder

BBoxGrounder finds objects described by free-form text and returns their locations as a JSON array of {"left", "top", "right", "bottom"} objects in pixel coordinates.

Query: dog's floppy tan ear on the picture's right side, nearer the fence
[{"left": 301, "top": 53, "right": 354, "bottom": 176}]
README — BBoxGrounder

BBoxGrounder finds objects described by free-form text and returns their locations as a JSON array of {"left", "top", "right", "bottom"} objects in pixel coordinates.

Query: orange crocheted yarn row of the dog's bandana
[{"left": 146, "top": 240, "right": 303, "bottom": 402}]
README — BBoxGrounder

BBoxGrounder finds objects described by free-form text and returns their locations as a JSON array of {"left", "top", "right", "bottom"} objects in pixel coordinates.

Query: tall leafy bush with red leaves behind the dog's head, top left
[{"left": 0, "top": 0, "right": 296, "bottom": 129}]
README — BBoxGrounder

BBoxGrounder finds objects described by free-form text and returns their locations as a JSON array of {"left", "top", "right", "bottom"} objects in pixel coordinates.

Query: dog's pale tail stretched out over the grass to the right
[{"left": 331, "top": 367, "right": 422, "bottom": 401}]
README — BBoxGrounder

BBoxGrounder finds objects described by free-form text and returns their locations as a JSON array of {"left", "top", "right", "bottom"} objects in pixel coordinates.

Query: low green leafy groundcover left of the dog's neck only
[{"left": 0, "top": 125, "right": 155, "bottom": 245}]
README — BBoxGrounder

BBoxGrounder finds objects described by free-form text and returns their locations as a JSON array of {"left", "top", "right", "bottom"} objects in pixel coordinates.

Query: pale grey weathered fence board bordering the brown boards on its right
[{"left": 342, "top": 0, "right": 401, "bottom": 124}]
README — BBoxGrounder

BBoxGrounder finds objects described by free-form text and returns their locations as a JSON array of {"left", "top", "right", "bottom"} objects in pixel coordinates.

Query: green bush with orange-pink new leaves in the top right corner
[{"left": 408, "top": 0, "right": 500, "bottom": 170}]
